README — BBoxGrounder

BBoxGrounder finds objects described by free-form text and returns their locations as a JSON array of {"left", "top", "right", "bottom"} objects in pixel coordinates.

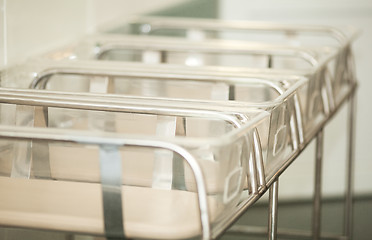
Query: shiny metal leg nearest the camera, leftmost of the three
[{"left": 268, "top": 179, "right": 279, "bottom": 240}]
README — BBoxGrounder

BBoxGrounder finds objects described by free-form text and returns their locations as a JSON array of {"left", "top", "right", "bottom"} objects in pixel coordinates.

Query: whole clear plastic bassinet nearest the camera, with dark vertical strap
[{"left": 0, "top": 89, "right": 270, "bottom": 239}]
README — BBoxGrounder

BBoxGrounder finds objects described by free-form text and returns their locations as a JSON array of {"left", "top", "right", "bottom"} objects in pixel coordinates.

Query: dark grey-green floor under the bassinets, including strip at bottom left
[{"left": 0, "top": 195, "right": 372, "bottom": 240}]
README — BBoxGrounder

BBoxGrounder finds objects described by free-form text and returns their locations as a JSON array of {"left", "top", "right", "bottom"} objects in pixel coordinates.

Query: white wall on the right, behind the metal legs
[{"left": 220, "top": 0, "right": 372, "bottom": 197}]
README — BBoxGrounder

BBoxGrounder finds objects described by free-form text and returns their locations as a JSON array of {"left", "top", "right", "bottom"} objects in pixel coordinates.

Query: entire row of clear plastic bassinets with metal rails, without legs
[{"left": 0, "top": 17, "right": 356, "bottom": 239}]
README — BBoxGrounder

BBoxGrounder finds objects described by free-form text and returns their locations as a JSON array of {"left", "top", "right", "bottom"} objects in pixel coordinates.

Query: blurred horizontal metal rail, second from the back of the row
[{"left": 84, "top": 34, "right": 322, "bottom": 66}]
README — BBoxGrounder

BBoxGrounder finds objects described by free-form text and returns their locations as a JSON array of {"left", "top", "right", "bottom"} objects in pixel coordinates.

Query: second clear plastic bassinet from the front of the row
[{"left": 3, "top": 58, "right": 308, "bottom": 185}]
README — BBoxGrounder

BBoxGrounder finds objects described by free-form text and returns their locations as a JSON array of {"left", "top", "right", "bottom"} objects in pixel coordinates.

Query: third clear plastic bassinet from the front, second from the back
[{"left": 38, "top": 32, "right": 356, "bottom": 141}]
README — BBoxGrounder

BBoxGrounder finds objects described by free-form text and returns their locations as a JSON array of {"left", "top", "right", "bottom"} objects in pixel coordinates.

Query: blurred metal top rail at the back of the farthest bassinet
[{"left": 112, "top": 16, "right": 358, "bottom": 44}]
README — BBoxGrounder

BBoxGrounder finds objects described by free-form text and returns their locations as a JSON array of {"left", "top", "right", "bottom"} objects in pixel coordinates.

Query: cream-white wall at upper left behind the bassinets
[{"left": 0, "top": 0, "right": 185, "bottom": 66}]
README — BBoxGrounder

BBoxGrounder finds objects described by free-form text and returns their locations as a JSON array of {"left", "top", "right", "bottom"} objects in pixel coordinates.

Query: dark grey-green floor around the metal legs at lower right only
[{"left": 222, "top": 196, "right": 372, "bottom": 240}]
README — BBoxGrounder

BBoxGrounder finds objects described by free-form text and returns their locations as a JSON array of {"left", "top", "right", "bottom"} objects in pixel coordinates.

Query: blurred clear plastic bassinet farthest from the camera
[{"left": 107, "top": 16, "right": 359, "bottom": 108}]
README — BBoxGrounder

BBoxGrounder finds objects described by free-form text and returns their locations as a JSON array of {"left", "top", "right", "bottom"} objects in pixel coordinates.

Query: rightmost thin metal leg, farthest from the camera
[{"left": 344, "top": 94, "right": 356, "bottom": 239}]
